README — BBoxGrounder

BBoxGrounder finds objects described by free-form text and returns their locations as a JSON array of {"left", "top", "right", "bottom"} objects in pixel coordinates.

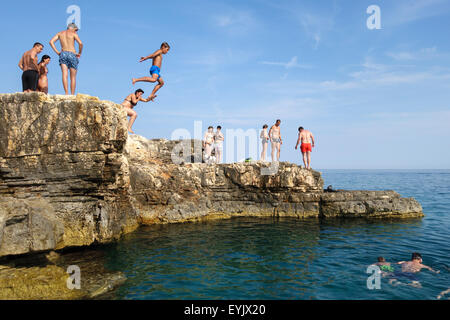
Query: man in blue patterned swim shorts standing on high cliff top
[{"left": 50, "top": 23, "right": 83, "bottom": 95}]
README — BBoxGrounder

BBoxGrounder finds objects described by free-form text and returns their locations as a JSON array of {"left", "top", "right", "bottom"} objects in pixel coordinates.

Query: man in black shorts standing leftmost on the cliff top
[{"left": 19, "top": 42, "right": 44, "bottom": 92}]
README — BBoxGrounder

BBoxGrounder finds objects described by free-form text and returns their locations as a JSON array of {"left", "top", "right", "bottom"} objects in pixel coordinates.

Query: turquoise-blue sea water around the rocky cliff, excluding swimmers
[{"left": 100, "top": 170, "right": 450, "bottom": 300}]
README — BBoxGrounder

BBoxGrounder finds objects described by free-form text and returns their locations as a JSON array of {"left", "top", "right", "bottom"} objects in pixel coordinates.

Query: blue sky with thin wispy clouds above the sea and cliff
[{"left": 0, "top": 0, "right": 450, "bottom": 169}]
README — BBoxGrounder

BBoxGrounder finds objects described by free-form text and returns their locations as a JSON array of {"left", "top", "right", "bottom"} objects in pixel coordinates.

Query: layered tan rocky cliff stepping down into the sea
[{"left": 0, "top": 93, "right": 423, "bottom": 257}]
